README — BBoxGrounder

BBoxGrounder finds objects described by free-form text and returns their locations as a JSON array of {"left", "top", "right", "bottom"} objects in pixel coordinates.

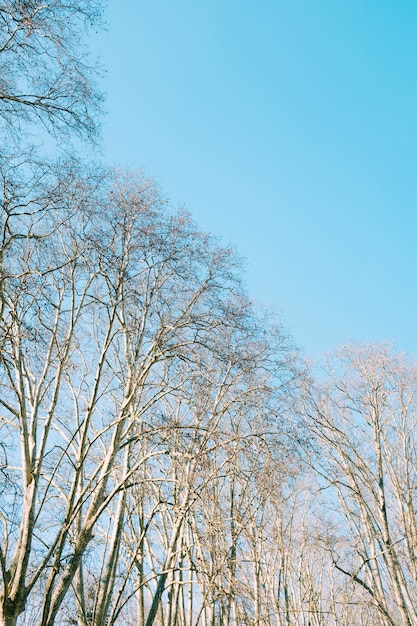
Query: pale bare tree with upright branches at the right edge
[{"left": 308, "top": 345, "right": 417, "bottom": 626}]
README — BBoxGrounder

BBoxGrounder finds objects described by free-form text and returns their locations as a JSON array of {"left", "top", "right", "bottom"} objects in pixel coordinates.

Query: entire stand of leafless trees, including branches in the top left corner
[{"left": 0, "top": 0, "right": 417, "bottom": 626}]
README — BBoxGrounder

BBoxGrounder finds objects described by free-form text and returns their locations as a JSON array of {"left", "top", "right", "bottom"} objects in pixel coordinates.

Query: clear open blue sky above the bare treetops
[{"left": 91, "top": 0, "right": 417, "bottom": 358}]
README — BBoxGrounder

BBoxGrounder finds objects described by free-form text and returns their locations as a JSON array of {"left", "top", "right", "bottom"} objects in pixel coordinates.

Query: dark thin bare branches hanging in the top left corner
[{"left": 0, "top": 0, "right": 103, "bottom": 146}]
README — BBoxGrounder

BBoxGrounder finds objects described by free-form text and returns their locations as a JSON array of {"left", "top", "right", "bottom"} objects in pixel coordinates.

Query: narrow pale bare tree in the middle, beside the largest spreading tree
[{"left": 80, "top": 305, "right": 300, "bottom": 626}]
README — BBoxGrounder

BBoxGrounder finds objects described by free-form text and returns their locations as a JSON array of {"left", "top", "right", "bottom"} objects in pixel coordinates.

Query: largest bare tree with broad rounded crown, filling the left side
[{"left": 0, "top": 168, "right": 300, "bottom": 626}]
